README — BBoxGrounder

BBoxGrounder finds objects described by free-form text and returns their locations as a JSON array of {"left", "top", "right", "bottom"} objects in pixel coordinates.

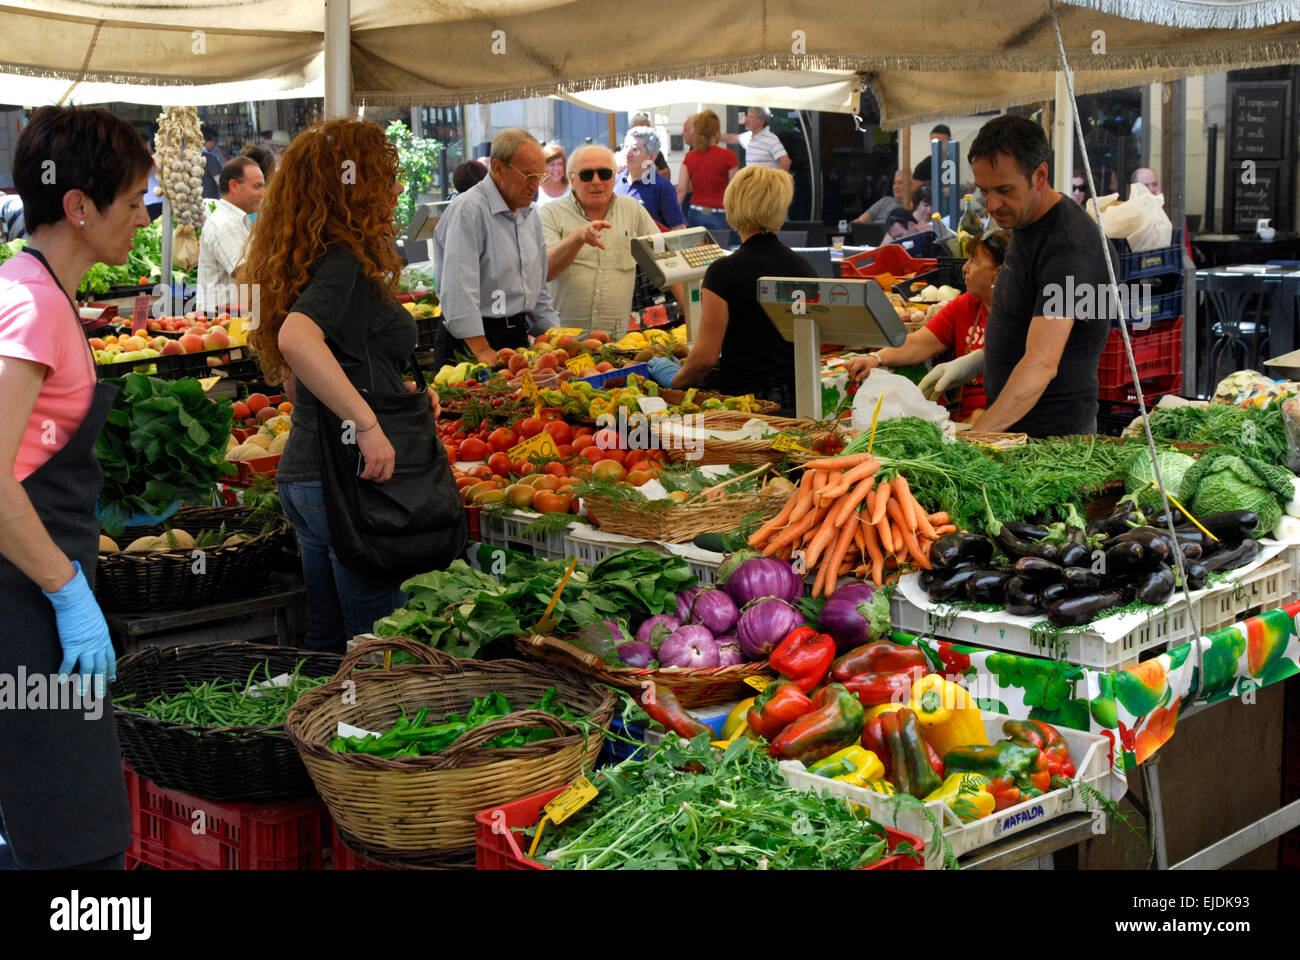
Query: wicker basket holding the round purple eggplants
[{"left": 515, "top": 633, "right": 775, "bottom": 706}]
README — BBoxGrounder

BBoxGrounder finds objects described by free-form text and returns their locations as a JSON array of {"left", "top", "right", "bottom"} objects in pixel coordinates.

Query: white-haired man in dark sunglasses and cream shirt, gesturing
[{"left": 541, "top": 144, "right": 658, "bottom": 340}]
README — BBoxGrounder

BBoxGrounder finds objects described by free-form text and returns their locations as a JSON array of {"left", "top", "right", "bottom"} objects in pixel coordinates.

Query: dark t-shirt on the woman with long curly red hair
[{"left": 276, "top": 247, "right": 416, "bottom": 483}]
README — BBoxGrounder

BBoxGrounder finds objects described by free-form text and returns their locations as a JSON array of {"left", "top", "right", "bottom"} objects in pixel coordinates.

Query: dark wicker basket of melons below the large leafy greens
[{"left": 95, "top": 507, "right": 289, "bottom": 613}]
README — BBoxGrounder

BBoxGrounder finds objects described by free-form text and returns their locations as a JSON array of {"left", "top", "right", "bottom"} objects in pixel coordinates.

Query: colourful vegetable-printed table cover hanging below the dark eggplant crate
[{"left": 896, "top": 601, "right": 1300, "bottom": 800}]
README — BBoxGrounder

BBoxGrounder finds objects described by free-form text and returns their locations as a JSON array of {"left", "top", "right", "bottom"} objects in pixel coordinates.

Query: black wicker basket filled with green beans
[{"left": 111, "top": 641, "right": 343, "bottom": 803}]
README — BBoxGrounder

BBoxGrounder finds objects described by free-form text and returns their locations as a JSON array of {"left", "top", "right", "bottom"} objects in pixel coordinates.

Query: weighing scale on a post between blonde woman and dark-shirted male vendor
[{"left": 758, "top": 277, "right": 907, "bottom": 420}]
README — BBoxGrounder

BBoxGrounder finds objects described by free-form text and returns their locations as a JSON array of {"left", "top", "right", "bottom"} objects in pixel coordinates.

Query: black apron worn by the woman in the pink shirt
[{"left": 0, "top": 248, "right": 131, "bottom": 868}]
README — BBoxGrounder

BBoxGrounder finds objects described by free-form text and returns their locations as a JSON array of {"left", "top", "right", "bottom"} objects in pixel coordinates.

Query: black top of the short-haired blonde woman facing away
[{"left": 703, "top": 233, "right": 816, "bottom": 394}]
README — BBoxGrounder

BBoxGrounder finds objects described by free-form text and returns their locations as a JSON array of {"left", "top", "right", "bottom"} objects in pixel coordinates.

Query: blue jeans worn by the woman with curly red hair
[{"left": 280, "top": 483, "right": 406, "bottom": 653}]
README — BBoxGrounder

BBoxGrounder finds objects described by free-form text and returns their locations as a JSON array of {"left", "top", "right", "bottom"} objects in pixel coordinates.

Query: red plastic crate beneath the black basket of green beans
[{"left": 124, "top": 764, "right": 330, "bottom": 870}]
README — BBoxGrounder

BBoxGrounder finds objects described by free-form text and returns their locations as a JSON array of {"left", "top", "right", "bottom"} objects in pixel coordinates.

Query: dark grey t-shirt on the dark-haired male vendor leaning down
[{"left": 984, "top": 196, "right": 1114, "bottom": 437}]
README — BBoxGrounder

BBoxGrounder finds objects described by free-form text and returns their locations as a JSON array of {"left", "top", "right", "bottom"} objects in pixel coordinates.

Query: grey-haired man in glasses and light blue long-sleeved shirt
[{"left": 433, "top": 127, "right": 559, "bottom": 364}]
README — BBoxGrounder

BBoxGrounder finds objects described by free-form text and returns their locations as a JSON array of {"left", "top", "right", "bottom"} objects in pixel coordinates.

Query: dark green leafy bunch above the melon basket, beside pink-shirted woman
[{"left": 95, "top": 373, "right": 234, "bottom": 536}]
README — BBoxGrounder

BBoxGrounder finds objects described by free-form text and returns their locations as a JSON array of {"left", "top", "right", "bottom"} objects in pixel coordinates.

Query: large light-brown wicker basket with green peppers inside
[{"left": 285, "top": 637, "right": 618, "bottom": 866}]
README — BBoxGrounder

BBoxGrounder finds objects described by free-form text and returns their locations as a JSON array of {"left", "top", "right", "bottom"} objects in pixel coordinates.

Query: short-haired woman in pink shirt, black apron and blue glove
[{"left": 0, "top": 107, "right": 153, "bottom": 869}]
